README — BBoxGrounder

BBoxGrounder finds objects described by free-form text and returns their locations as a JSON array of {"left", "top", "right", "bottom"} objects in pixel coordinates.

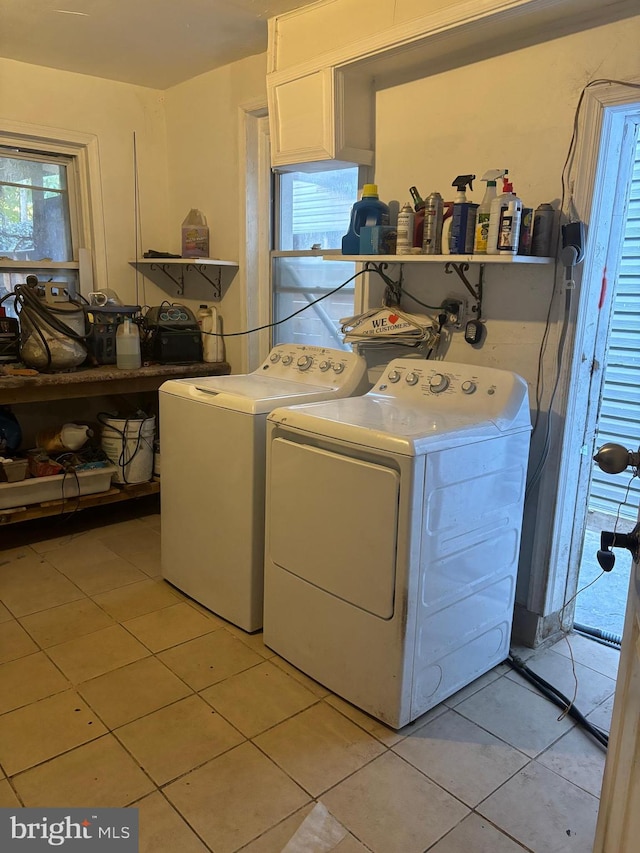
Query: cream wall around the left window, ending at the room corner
[{"left": 0, "top": 58, "right": 168, "bottom": 302}]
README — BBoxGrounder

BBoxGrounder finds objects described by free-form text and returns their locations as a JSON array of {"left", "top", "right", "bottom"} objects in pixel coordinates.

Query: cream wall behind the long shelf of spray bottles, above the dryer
[{"left": 375, "top": 18, "right": 640, "bottom": 624}]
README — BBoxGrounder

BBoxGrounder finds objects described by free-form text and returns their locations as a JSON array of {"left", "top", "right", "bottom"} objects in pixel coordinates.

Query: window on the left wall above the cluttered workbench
[{"left": 0, "top": 146, "right": 79, "bottom": 314}]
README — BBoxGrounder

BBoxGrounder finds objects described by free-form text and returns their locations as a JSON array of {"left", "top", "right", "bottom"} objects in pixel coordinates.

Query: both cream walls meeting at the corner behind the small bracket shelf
[{"left": 0, "top": 54, "right": 266, "bottom": 372}]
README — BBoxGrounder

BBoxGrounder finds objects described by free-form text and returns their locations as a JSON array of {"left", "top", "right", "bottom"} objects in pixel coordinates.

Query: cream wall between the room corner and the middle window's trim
[{"left": 165, "top": 54, "right": 267, "bottom": 373}]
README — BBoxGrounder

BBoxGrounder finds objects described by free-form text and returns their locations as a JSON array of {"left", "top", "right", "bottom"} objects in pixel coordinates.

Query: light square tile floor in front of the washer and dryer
[{"left": 0, "top": 504, "right": 618, "bottom": 853}]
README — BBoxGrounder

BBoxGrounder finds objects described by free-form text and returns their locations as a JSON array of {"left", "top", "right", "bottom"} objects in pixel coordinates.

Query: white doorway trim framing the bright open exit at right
[{"left": 531, "top": 81, "right": 640, "bottom": 630}]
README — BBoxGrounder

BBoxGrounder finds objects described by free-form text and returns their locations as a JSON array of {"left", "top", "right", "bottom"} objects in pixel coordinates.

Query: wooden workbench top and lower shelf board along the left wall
[{"left": 0, "top": 361, "right": 231, "bottom": 526}]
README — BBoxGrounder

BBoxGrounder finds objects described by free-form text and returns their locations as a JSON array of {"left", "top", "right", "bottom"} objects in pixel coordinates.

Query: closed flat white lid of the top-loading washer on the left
[{"left": 160, "top": 373, "right": 338, "bottom": 415}]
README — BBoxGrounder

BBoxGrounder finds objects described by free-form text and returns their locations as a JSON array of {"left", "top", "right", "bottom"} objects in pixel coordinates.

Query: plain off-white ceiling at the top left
[{"left": 0, "top": 0, "right": 315, "bottom": 89}]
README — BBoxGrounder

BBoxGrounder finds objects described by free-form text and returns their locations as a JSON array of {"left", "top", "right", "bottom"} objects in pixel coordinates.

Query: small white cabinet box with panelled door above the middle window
[{"left": 268, "top": 68, "right": 374, "bottom": 169}]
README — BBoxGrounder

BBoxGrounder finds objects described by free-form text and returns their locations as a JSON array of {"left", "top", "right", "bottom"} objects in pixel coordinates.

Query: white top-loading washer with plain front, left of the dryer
[{"left": 159, "top": 344, "right": 371, "bottom": 631}]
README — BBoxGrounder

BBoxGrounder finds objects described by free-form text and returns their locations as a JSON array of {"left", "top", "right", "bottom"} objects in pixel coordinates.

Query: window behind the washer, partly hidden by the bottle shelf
[{"left": 271, "top": 166, "right": 358, "bottom": 349}]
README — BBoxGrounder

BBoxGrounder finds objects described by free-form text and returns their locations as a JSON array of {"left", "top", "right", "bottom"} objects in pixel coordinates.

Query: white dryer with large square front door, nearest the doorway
[{"left": 264, "top": 359, "right": 531, "bottom": 728}]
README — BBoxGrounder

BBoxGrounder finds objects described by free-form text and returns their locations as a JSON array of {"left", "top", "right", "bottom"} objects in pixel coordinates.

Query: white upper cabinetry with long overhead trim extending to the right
[{"left": 267, "top": 0, "right": 637, "bottom": 170}]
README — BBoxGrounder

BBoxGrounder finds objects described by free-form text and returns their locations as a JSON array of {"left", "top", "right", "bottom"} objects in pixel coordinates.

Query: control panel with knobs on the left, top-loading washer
[{"left": 254, "top": 344, "right": 369, "bottom": 390}]
